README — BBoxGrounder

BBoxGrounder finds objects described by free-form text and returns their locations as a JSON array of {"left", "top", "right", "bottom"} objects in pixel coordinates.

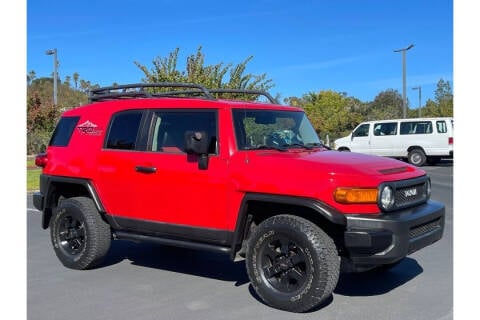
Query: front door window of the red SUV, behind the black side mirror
[{"left": 150, "top": 110, "right": 218, "bottom": 154}]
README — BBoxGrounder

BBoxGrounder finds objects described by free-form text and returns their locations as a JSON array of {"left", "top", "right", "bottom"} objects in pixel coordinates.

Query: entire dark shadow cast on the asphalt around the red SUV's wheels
[{"left": 99, "top": 240, "right": 423, "bottom": 302}]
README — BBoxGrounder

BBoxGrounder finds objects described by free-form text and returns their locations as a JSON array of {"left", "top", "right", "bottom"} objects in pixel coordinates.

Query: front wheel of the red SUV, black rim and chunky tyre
[{"left": 246, "top": 215, "right": 340, "bottom": 312}]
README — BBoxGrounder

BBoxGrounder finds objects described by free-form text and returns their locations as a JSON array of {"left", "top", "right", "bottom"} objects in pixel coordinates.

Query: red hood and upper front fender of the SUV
[{"left": 233, "top": 149, "right": 425, "bottom": 198}]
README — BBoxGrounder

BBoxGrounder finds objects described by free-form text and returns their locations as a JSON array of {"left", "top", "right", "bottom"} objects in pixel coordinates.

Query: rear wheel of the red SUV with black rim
[{"left": 50, "top": 197, "right": 111, "bottom": 270}]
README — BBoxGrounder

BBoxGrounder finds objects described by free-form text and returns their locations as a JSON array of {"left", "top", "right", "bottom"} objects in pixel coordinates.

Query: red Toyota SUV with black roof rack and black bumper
[{"left": 33, "top": 83, "right": 445, "bottom": 312}]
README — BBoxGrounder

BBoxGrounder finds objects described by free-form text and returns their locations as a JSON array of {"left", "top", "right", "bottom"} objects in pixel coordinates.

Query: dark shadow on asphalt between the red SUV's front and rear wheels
[{"left": 99, "top": 240, "right": 250, "bottom": 286}]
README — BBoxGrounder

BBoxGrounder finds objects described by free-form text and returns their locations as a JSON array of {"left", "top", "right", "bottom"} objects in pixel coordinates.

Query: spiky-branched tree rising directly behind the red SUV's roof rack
[{"left": 134, "top": 47, "right": 273, "bottom": 97}]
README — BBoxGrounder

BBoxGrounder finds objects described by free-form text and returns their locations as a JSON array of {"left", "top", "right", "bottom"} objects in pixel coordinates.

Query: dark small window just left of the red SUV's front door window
[{"left": 105, "top": 111, "right": 142, "bottom": 150}]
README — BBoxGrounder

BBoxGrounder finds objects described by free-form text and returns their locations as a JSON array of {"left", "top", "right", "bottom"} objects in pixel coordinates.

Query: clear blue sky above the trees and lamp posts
[{"left": 26, "top": 0, "right": 454, "bottom": 108}]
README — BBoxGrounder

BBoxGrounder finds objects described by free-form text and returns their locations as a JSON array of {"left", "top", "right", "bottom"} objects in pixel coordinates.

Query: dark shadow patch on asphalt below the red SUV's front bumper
[{"left": 334, "top": 257, "right": 423, "bottom": 296}]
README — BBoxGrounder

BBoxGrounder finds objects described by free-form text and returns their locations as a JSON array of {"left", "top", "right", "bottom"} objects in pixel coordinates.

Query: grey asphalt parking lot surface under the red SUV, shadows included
[{"left": 27, "top": 162, "right": 453, "bottom": 320}]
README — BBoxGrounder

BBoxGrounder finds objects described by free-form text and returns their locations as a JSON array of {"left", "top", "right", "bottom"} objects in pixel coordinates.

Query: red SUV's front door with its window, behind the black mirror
[{"left": 133, "top": 110, "right": 228, "bottom": 230}]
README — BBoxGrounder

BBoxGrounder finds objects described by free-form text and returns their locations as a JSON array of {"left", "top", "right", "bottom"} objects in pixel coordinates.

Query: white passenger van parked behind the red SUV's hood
[{"left": 334, "top": 118, "right": 453, "bottom": 166}]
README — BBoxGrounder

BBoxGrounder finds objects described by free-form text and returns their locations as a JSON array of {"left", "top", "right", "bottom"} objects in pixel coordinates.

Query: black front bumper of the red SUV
[{"left": 344, "top": 200, "right": 445, "bottom": 268}]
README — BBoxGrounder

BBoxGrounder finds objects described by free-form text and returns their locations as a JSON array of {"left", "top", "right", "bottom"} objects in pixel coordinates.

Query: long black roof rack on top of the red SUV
[{"left": 89, "top": 82, "right": 278, "bottom": 103}]
